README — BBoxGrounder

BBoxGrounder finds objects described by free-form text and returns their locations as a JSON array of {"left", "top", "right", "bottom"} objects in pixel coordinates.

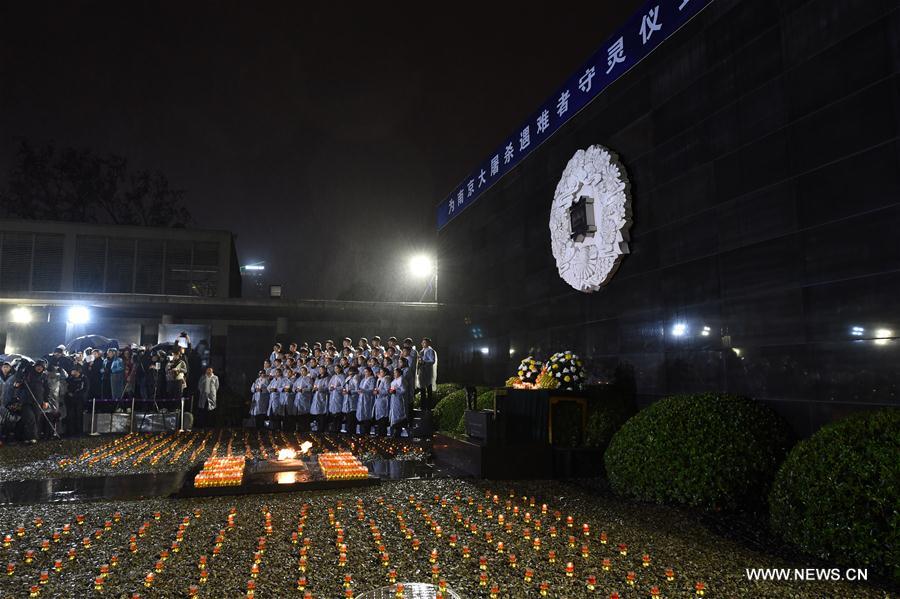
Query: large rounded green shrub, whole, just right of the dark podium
[{"left": 604, "top": 394, "right": 788, "bottom": 509}]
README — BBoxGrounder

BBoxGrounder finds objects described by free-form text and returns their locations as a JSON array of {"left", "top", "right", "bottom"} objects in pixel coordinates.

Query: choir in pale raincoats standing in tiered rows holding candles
[{"left": 250, "top": 336, "right": 437, "bottom": 437}]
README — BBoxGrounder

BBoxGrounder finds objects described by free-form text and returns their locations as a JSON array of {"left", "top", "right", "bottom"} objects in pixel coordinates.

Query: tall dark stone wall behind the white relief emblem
[{"left": 438, "top": 0, "right": 900, "bottom": 434}]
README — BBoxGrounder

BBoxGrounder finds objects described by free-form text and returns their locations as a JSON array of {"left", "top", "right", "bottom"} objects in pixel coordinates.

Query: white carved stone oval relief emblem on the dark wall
[{"left": 550, "top": 145, "right": 631, "bottom": 293}]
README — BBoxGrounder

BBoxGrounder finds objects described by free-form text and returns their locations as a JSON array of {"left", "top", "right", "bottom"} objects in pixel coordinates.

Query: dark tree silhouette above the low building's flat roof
[{"left": 0, "top": 140, "right": 194, "bottom": 227}]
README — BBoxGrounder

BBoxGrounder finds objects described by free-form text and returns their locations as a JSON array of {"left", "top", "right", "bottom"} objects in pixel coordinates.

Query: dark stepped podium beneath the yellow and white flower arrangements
[{"left": 433, "top": 388, "right": 593, "bottom": 479}]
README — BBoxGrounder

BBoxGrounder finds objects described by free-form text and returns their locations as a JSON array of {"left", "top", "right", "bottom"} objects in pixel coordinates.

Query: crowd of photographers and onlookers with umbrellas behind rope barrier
[{"left": 0, "top": 332, "right": 218, "bottom": 444}]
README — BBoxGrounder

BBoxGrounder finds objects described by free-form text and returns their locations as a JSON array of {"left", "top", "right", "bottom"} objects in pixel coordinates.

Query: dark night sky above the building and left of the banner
[{"left": 0, "top": 0, "right": 641, "bottom": 300}]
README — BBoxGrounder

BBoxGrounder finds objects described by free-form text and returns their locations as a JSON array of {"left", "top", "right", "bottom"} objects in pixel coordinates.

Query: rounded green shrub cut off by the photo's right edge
[{"left": 769, "top": 409, "right": 900, "bottom": 581}]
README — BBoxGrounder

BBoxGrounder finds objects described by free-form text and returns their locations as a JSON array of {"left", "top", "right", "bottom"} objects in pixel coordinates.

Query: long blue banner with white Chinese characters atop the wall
[{"left": 437, "top": 0, "right": 712, "bottom": 230}]
